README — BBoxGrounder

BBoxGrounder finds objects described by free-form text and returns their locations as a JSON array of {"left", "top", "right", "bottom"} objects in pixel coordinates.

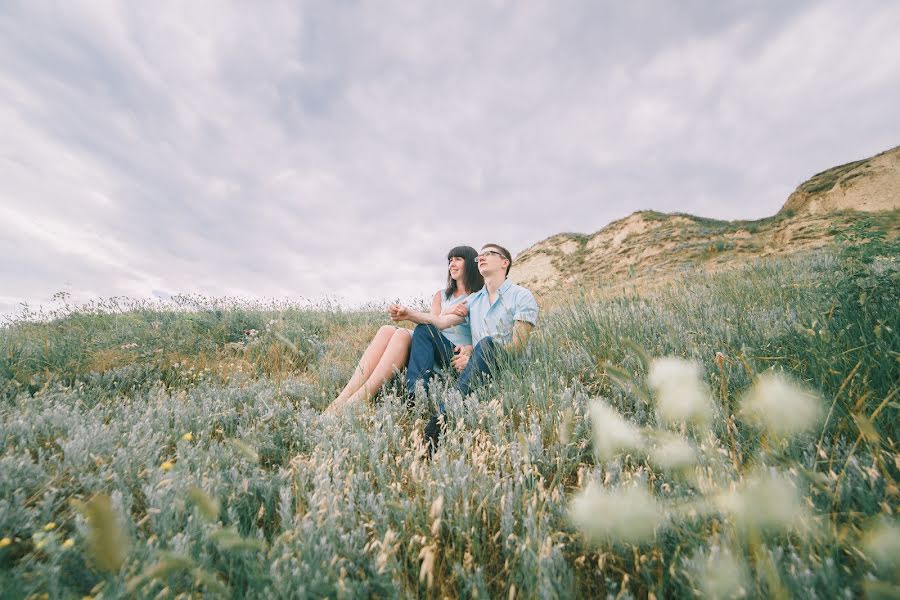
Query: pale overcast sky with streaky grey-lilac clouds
[{"left": 0, "top": 0, "right": 900, "bottom": 315}]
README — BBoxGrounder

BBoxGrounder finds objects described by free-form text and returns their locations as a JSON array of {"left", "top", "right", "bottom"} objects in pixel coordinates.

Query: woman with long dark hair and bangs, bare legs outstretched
[{"left": 325, "top": 246, "right": 484, "bottom": 414}]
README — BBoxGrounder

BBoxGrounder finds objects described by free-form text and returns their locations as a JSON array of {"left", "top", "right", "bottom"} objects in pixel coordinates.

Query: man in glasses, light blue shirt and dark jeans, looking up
[{"left": 390, "top": 244, "right": 538, "bottom": 448}]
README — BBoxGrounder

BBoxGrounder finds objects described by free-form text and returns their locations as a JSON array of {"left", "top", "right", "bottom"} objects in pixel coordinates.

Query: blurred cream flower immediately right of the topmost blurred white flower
[{"left": 740, "top": 371, "right": 821, "bottom": 437}]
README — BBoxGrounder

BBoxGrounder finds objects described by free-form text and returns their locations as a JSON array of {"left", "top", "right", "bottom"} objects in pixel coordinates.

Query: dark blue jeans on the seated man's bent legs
[{"left": 406, "top": 325, "right": 500, "bottom": 413}]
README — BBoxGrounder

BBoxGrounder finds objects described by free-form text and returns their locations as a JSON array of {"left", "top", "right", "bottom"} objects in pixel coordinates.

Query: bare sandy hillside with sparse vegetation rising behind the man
[{"left": 511, "top": 147, "right": 900, "bottom": 299}]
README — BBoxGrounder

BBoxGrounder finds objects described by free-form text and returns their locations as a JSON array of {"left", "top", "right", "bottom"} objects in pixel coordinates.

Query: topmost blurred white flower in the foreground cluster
[{"left": 648, "top": 356, "right": 713, "bottom": 424}]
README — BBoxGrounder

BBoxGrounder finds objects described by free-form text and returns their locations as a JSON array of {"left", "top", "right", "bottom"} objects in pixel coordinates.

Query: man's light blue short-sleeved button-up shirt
[{"left": 466, "top": 279, "right": 538, "bottom": 345}]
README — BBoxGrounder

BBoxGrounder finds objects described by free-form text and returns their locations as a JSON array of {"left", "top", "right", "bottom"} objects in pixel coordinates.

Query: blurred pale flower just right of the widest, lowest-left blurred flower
[{"left": 715, "top": 474, "right": 805, "bottom": 531}]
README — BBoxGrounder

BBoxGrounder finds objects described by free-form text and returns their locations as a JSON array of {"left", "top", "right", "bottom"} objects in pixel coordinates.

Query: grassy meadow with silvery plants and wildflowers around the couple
[{"left": 0, "top": 232, "right": 900, "bottom": 598}]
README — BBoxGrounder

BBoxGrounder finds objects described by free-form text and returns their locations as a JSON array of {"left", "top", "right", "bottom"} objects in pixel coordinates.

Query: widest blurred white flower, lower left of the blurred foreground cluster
[{"left": 569, "top": 482, "right": 665, "bottom": 543}]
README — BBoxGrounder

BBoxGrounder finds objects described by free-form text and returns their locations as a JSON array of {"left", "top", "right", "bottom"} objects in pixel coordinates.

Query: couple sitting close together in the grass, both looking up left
[{"left": 326, "top": 244, "right": 538, "bottom": 444}]
